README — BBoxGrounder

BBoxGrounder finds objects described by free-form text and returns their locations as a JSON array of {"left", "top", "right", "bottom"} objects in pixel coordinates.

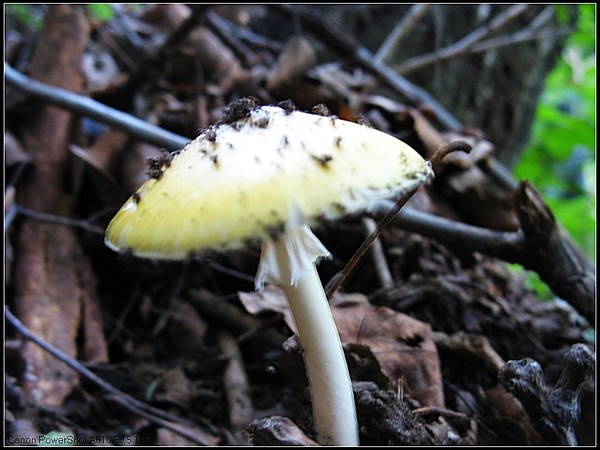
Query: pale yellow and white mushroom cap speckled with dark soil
[{"left": 105, "top": 106, "right": 433, "bottom": 260}]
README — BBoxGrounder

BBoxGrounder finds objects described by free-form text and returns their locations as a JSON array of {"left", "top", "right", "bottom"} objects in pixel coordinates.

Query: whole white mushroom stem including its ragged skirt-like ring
[{"left": 257, "top": 225, "right": 359, "bottom": 446}]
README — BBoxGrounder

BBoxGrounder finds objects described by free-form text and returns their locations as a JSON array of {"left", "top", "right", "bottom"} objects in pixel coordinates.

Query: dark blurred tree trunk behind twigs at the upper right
[{"left": 300, "top": 4, "right": 577, "bottom": 167}]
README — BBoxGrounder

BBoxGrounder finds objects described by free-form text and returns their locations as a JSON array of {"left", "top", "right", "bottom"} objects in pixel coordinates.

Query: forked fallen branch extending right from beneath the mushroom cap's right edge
[{"left": 374, "top": 182, "right": 596, "bottom": 323}]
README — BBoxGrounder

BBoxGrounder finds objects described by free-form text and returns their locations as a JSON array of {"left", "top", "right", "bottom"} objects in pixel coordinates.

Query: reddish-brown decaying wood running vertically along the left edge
[{"left": 15, "top": 5, "right": 108, "bottom": 405}]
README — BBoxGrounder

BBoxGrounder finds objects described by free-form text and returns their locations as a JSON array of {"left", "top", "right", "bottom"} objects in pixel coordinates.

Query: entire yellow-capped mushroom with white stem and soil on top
[{"left": 105, "top": 99, "right": 433, "bottom": 445}]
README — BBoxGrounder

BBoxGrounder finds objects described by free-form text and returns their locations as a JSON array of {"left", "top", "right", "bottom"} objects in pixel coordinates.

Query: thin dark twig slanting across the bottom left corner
[{"left": 4, "top": 306, "right": 218, "bottom": 445}]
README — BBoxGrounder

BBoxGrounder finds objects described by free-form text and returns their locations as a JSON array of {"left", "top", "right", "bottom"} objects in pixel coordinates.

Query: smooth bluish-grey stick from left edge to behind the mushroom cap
[{"left": 4, "top": 62, "right": 191, "bottom": 150}]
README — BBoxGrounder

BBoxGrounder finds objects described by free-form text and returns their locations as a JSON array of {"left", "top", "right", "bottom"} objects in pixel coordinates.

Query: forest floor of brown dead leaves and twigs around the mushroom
[{"left": 5, "top": 4, "right": 596, "bottom": 446}]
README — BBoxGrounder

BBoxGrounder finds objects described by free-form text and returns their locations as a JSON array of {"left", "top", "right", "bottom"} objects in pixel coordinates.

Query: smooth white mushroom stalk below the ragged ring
[{"left": 283, "top": 265, "right": 358, "bottom": 446}]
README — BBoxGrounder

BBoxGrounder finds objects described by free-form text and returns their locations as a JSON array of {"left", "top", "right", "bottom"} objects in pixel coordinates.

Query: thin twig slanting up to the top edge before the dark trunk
[{"left": 395, "top": 4, "right": 529, "bottom": 75}]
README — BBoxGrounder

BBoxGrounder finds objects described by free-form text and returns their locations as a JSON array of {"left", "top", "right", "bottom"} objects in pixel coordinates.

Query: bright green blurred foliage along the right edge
[{"left": 515, "top": 4, "right": 596, "bottom": 266}]
